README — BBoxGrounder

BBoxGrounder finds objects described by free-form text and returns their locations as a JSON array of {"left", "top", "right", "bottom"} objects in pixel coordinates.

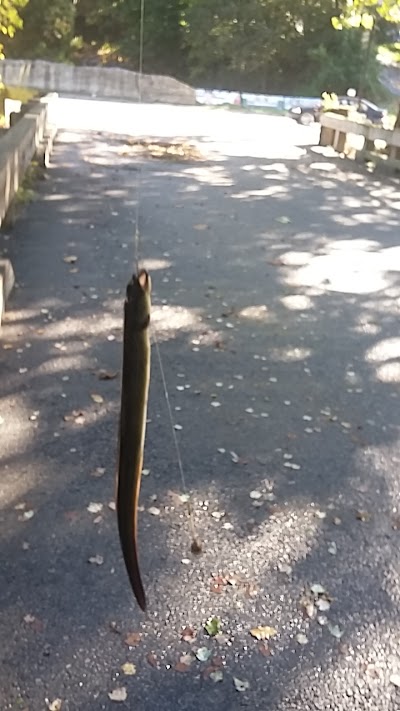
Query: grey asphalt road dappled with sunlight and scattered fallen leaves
[{"left": 0, "top": 103, "right": 400, "bottom": 711}]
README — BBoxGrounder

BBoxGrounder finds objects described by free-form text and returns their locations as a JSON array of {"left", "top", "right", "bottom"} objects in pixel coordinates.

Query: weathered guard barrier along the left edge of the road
[{"left": 0, "top": 95, "right": 54, "bottom": 325}]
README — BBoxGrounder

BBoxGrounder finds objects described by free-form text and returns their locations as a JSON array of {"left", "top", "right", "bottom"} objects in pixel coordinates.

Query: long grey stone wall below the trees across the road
[{"left": 0, "top": 59, "right": 196, "bottom": 104}]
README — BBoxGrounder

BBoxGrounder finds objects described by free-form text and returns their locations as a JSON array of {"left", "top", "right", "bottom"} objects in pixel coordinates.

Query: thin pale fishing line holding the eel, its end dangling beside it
[{"left": 134, "top": 0, "right": 201, "bottom": 553}]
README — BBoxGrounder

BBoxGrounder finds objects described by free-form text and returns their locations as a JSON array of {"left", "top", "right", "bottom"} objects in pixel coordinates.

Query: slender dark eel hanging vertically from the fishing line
[{"left": 116, "top": 269, "right": 151, "bottom": 611}]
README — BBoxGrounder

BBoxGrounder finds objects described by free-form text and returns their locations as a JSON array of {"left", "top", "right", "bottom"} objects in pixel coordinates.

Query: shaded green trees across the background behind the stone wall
[{"left": 2, "top": 0, "right": 400, "bottom": 94}]
